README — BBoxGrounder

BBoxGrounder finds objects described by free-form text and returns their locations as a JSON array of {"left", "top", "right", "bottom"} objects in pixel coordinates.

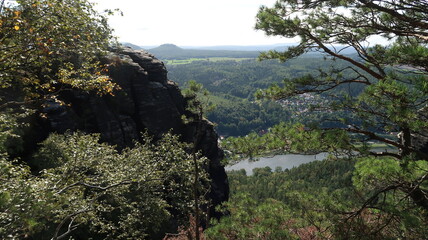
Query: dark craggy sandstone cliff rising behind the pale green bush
[{"left": 43, "top": 48, "right": 229, "bottom": 217}]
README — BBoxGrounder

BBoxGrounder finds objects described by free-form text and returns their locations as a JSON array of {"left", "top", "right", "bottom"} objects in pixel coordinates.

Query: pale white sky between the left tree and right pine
[{"left": 91, "top": 0, "right": 290, "bottom": 46}]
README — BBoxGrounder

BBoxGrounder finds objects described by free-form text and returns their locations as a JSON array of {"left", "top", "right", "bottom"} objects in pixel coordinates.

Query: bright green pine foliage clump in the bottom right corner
[{"left": 349, "top": 158, "right": 428, "bottom": 239}]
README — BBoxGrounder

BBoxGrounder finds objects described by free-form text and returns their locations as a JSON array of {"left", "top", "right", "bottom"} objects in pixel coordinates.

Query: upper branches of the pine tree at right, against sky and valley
[{"left": 256, "top": 0, "right": 428, "bottom": 147}]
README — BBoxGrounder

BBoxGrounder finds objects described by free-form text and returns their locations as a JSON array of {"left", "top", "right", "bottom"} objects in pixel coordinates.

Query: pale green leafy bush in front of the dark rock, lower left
[{"left": 0, "top": 133, "right": 206, "bottom": 239}]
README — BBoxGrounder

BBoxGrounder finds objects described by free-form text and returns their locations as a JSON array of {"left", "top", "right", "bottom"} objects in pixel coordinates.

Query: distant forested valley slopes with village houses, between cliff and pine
[{"left": 167, "top": 56, "right": 361, "bottom": 136}]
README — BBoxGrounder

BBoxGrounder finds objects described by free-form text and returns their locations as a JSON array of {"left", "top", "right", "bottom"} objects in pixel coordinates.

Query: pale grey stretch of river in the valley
[{"left": 225, "top": 153, "right": 327, "bottom": 175}]
